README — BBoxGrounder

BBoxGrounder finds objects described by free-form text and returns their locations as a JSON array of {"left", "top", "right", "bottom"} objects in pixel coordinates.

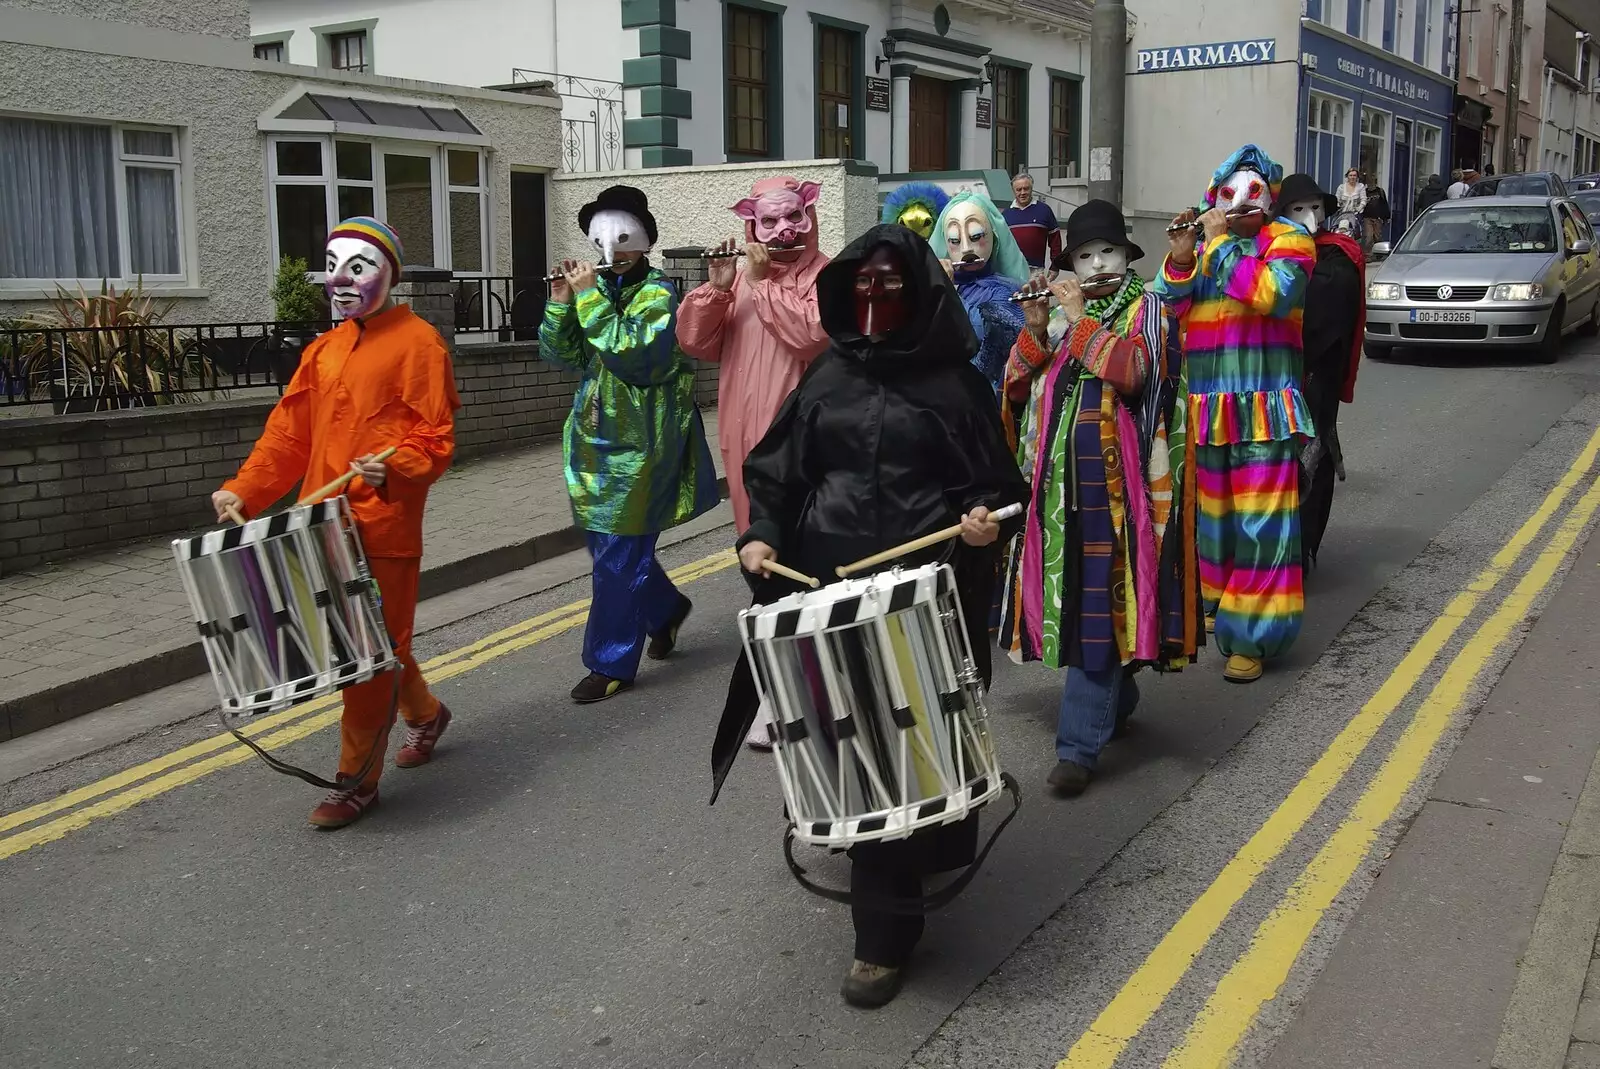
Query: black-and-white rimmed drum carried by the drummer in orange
[{"left": 173, "top": 498, "right": 395, "bottom": 722}]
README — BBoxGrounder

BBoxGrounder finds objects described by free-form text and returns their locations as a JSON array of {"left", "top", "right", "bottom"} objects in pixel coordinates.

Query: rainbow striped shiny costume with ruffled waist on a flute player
[{"left": 1155, "top": 146, "right": 1317, "bottom": 658}]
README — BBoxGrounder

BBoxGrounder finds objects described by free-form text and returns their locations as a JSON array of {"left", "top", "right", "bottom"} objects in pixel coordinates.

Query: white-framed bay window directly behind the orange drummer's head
[{"left": 267, "top": 138, "right": 490, "bottom": 275}]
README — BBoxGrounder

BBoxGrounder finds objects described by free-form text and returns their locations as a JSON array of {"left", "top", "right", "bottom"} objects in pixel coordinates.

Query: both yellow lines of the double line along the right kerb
[{"left": 1058, "top": 430, "right": 1600, "bottom": 1069}]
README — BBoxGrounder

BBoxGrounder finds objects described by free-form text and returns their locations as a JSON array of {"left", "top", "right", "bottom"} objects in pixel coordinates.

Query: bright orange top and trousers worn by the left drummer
[{"left": 222, "top": 304, "right": 461, "bottom": 787}]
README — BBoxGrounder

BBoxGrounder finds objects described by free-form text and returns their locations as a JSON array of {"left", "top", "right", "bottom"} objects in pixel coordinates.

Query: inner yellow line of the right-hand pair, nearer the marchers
[{"left": 1056, "top": 430, "right": 1600, "bottom": 1069}]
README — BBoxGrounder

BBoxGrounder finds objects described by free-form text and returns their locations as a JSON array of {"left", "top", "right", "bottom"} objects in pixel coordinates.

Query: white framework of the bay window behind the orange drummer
[{"left": 266, "top": 133, "right": 496, "bottom": 282}]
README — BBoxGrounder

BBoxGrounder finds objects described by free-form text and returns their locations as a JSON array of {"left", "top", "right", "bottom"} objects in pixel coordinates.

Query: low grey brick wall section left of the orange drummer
[{"left": 0, "top": 398, "right": 274, "bottom": 573}]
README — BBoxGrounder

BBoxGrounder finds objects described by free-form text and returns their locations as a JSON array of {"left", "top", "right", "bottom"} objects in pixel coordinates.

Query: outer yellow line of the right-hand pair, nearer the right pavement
[{"left": 1163, "top": 464, "right": 1600, "bottom": 1069}]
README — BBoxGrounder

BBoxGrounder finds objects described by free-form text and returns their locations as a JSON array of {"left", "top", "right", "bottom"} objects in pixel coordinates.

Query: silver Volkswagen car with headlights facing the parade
[{"left": 1366, "top": 197, "right": 1600, "bottom": 363}]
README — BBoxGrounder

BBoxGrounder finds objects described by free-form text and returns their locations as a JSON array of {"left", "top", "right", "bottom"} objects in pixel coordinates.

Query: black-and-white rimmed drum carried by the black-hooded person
[{"left": 739, "top": 565, "right": 1002, "bottom": 848}]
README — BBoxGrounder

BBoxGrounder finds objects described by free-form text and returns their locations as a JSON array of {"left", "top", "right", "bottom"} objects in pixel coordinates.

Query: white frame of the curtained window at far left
[{"left": 0, "top": 110, "right": 197, "bottom": 289}]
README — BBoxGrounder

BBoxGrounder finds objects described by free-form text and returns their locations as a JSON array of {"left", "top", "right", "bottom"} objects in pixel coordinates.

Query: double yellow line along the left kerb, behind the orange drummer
[{"left": 0, "top": 551, "right": 738, "bottom": 859}]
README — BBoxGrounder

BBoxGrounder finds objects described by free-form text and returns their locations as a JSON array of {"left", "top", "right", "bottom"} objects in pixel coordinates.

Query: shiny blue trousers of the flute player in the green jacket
[{"left": 584, "top": 531, "right": 685, "bottom": 682}]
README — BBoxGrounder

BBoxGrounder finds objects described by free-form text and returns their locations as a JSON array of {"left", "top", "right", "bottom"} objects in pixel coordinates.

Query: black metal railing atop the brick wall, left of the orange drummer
[{"left": 0, "top": 322, "right": 330, "bottom": 414}]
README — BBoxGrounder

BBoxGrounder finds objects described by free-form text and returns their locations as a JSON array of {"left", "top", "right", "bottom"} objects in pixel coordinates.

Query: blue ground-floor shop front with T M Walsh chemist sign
[{"left": 1296, "top": 21, "right": 1456, "bottom": 235}]
